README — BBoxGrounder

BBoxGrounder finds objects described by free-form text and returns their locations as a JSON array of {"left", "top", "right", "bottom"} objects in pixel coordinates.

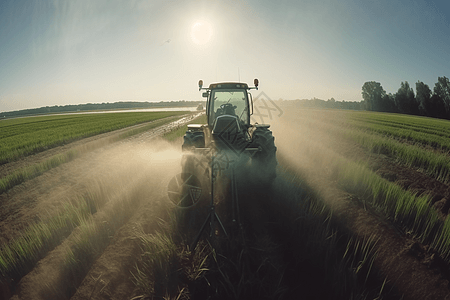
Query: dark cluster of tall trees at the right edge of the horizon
[{"left": 362, "top": 76, "right": 450, "bottom": 119}]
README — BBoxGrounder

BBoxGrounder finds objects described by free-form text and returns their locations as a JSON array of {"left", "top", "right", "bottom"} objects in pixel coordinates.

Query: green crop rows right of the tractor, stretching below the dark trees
[{"left": 275, "top": 109, "right": 450, "bottom": 261}]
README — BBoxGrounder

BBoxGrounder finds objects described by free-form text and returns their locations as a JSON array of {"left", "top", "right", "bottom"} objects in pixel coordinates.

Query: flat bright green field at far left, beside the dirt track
[{"left": 0, "top": 112, "right": 190, "bottom": 193}]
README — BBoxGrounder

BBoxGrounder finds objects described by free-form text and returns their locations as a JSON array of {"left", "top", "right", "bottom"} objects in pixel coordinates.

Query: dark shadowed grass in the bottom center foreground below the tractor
[{"left": 133, "top": 166, "right": 385, "bottom": 299}]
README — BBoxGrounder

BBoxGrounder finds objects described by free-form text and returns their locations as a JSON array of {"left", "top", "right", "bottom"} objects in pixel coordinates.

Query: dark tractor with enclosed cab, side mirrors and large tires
[{"left": 182, "top": 79, "right": 277, "bottom": 185}]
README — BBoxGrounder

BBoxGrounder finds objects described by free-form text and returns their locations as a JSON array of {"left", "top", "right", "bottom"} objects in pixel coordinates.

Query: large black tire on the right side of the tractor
[{"left": 251, "top": 128, "right": 278, "bottom": 184}]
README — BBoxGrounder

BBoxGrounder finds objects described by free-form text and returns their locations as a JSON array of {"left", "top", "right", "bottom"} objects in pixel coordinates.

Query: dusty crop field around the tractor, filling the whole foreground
[{"left": 0, "top": 107, "right": 450, "bottom": 299}]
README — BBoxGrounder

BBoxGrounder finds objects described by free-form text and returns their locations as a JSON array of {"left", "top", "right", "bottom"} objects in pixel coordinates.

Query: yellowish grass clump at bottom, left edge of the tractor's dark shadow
[{"left": 132, "top": 201, "right": 207, "bottom": 299}]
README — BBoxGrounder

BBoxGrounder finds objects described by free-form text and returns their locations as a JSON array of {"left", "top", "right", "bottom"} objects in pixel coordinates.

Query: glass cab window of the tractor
[{"left": 210, "top": 89, "right": 250, "bottom": 125}]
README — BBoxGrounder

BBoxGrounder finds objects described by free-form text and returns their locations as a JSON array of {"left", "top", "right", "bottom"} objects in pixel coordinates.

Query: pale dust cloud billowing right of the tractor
[{"left": 270, "top": 109, "right": 352, "bottom": 209}]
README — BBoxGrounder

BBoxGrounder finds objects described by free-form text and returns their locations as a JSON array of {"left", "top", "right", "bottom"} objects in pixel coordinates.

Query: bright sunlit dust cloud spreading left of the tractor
[{"left": 6, "top": 138, "right": 186, "bottom": 299}]
